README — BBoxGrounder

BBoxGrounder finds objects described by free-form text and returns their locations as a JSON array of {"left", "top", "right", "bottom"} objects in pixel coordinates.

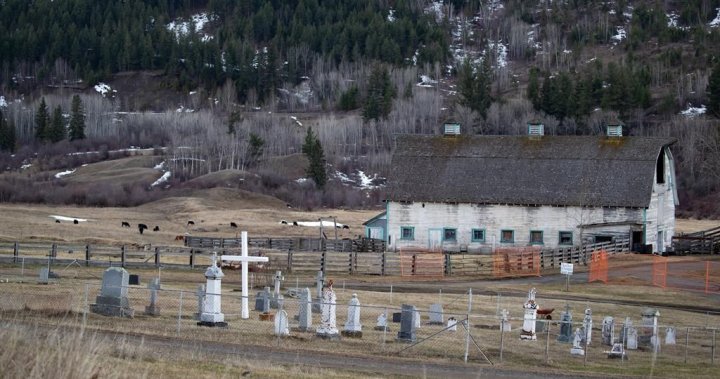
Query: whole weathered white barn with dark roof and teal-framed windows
[{"left": 385, "top": 125, "right": 678, "bottom": 252}]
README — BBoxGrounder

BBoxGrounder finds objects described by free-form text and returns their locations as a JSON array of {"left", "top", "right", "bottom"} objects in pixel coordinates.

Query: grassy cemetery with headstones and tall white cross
[{"left": 0, "top": 233, "right": 720, "bottom": 377}]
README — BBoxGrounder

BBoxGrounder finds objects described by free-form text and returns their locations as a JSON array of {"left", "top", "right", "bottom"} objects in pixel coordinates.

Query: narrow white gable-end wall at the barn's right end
[{"left": 645, "top": 148, "right": 676, "bottom": 252}]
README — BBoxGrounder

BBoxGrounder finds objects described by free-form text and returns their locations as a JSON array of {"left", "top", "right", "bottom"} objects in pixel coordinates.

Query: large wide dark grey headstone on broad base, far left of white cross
[{"left": 90, "top": 267, "right": 135, "bottom": 318}]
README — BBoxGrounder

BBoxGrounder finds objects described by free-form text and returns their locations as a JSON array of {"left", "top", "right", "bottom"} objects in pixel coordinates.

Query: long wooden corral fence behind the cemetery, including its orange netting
[{"left": 0, "top": 238, "right": 629, "bottom": 277}]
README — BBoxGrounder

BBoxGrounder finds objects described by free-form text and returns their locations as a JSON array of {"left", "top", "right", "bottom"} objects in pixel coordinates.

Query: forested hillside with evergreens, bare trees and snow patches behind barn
[{"left": 0, "top": 0, "right": 720, "bottom": 216}]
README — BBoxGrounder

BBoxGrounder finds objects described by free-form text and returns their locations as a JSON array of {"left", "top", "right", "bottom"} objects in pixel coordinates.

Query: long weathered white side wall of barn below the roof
[{"left": 386, "top": 202, "right": 643, "bottom": 252}]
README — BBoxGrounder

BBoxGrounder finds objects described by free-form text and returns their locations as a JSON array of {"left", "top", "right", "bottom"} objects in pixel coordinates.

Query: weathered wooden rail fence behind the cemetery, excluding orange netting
[{"left": 0, "top": 239, "right": 629, "bottom": 277}]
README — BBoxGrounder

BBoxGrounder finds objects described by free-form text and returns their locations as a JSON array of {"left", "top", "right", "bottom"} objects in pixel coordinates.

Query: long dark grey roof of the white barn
[{"left": 388, "top": 135, "right": 677, "bottom": 208}]
